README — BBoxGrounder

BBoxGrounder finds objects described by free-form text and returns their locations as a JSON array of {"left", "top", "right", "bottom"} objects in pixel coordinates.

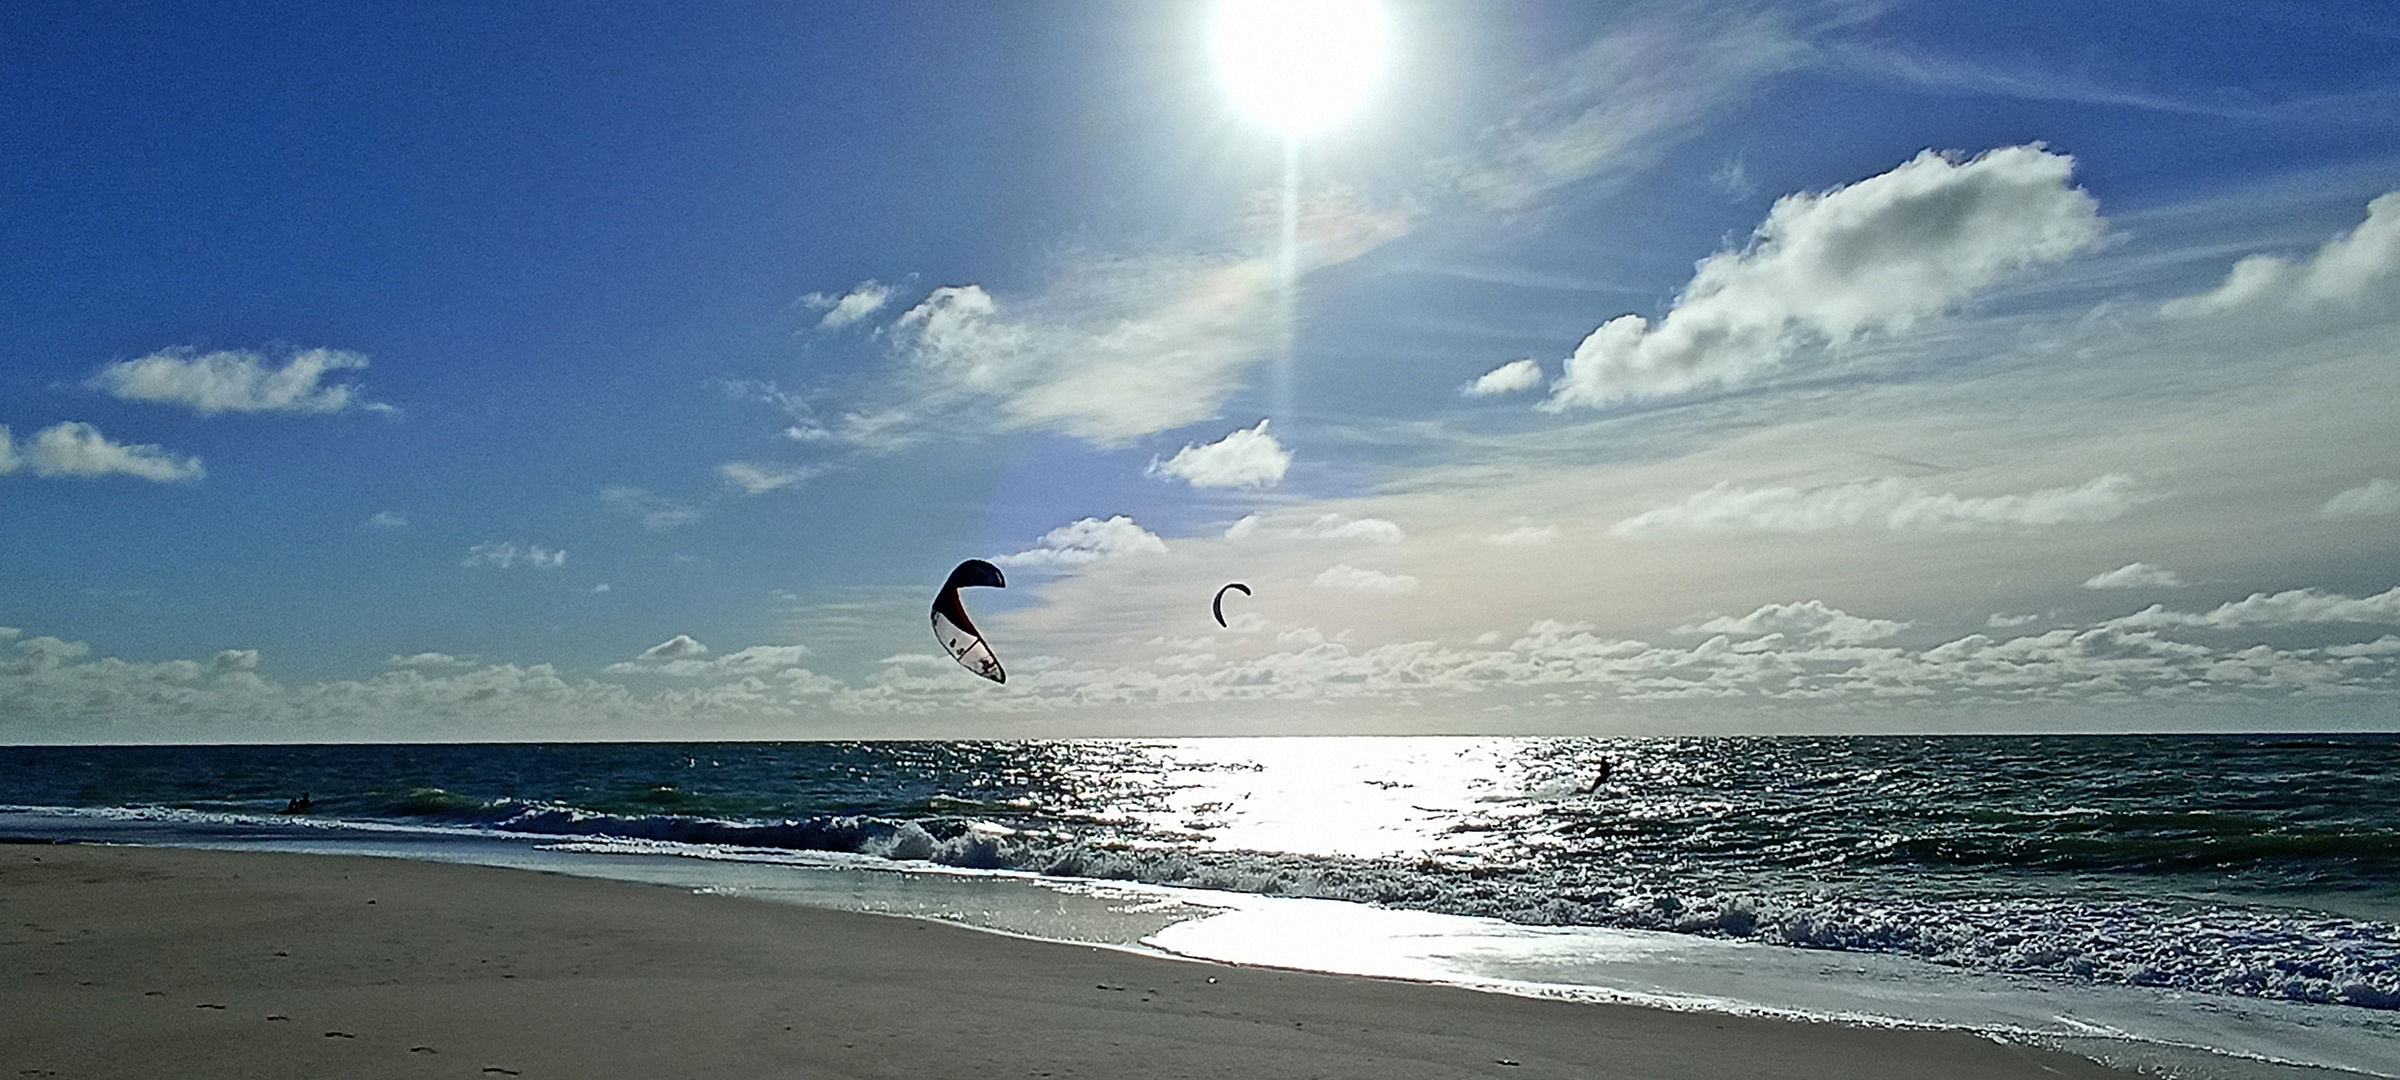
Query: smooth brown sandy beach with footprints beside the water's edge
[{"left": 0, "top": 845, "right": 2129, "bottom": 1080}]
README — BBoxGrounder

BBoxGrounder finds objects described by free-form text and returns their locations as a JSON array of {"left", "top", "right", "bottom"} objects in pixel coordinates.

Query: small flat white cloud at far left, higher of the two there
[{"left": 91, "top": 348, "right": 391, "bottom": 415}]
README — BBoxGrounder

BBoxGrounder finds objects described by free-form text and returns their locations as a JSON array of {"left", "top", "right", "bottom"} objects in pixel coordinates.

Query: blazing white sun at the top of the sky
[{"left": 1212, "top": 0, "right": 1390, "bottom": 139}]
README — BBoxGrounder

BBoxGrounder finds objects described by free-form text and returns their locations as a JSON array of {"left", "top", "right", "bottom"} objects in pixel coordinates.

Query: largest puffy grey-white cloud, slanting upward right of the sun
[{"left": 1541, "top": 146, "right": 2105, "bottom": 410}]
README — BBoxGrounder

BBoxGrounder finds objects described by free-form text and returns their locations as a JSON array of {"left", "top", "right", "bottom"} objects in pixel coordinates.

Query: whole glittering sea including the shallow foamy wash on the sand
[{"left": 0, "top": 734, "right": 2400, "bottom": 1080}]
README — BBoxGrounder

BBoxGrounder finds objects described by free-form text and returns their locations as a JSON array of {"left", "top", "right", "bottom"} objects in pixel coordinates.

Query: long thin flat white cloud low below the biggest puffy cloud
[{"left": 1608, "top": 473, "right": 2141, "bottom": 538}]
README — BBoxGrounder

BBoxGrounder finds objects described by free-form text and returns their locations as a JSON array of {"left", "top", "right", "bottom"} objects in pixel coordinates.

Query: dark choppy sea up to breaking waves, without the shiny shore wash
[{"left": 0, "top": 737, "right": 2400, "bottom": 1010}]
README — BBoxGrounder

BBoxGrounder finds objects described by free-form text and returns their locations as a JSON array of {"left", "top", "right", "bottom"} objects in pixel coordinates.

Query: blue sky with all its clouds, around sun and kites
[{"left": 0, "top": 0, "right": 2400, "bottom": 742}]
